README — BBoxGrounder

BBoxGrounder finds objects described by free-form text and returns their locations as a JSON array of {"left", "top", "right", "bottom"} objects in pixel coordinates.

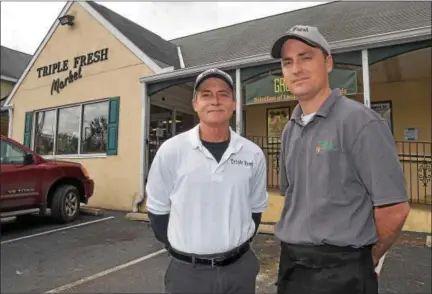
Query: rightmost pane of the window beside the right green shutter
[{"left": 81, "top": 101, "right": 109, "bottom": 154}]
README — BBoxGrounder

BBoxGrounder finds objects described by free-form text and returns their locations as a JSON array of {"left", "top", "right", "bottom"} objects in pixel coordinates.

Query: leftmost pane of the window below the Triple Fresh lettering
[{"left": 35, "top": 110, "right": 56, "bottom": 155}]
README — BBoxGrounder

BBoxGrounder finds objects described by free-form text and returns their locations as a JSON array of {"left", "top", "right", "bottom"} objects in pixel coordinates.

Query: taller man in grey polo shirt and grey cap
[{"left": 271, "top": 25, "right": 409, "bottom": 294}]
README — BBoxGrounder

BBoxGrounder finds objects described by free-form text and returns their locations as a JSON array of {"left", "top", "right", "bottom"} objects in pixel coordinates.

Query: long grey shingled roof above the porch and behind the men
[{"left": 170, "top": 1, "right": 431, "bottom": 67}]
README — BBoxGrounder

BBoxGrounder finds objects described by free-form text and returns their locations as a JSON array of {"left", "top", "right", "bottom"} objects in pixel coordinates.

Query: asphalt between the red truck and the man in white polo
[{"left": 1, "top": 213, "right": 168, "bottom": 293}]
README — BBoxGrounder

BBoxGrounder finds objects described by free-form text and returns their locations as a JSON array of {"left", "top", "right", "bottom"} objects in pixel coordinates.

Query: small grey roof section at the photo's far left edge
[{"left": 0, "top": 46, "right": 32, "bottom": 82}]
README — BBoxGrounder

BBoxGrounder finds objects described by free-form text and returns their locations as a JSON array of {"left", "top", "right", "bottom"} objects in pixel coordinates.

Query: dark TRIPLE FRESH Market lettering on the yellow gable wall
[{"left": 36, "top": 48, "right": 108, "bottom": 95}]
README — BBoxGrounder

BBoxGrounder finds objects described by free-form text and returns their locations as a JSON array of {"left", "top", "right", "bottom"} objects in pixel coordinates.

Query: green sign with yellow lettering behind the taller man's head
[{"left": 245, "top": 68, "right": 357, "bottom": 105}]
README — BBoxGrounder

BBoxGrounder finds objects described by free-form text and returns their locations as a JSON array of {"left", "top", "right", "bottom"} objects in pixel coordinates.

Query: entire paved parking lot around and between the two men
[{"left": 1, "top": 212, "right": 431, "bottom": 294}]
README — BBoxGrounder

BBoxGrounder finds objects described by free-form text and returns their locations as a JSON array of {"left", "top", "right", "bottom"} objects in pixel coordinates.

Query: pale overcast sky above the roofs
[{"left": 0, "top": 1, "right": 324, "bottom": 54}]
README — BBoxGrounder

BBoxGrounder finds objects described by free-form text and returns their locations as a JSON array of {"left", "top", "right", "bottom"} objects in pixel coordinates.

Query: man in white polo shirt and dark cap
[{"left": 147, "top": 69, "right": 267, "bottom": 294}]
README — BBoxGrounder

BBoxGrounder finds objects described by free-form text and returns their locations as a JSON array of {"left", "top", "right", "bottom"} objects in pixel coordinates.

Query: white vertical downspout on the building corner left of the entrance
[{"left": 132, "top": 82, "right": 150, "bottom": 212}]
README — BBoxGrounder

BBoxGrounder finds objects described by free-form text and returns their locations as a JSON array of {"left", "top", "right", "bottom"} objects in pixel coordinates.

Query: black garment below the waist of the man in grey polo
[{"left": 277, "top": 243, "right": 378, "bottom": 294}]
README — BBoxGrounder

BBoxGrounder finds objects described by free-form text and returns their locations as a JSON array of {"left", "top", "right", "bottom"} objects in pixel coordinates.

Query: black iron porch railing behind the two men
[{"left": 149, "top": 136, "right": 432, "bottom": 205}]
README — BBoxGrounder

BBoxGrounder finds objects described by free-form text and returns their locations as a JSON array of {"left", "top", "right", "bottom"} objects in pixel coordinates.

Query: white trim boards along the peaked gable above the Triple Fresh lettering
[{"left": 4, "top": 1, "right": 165, "bottom": 107}]
